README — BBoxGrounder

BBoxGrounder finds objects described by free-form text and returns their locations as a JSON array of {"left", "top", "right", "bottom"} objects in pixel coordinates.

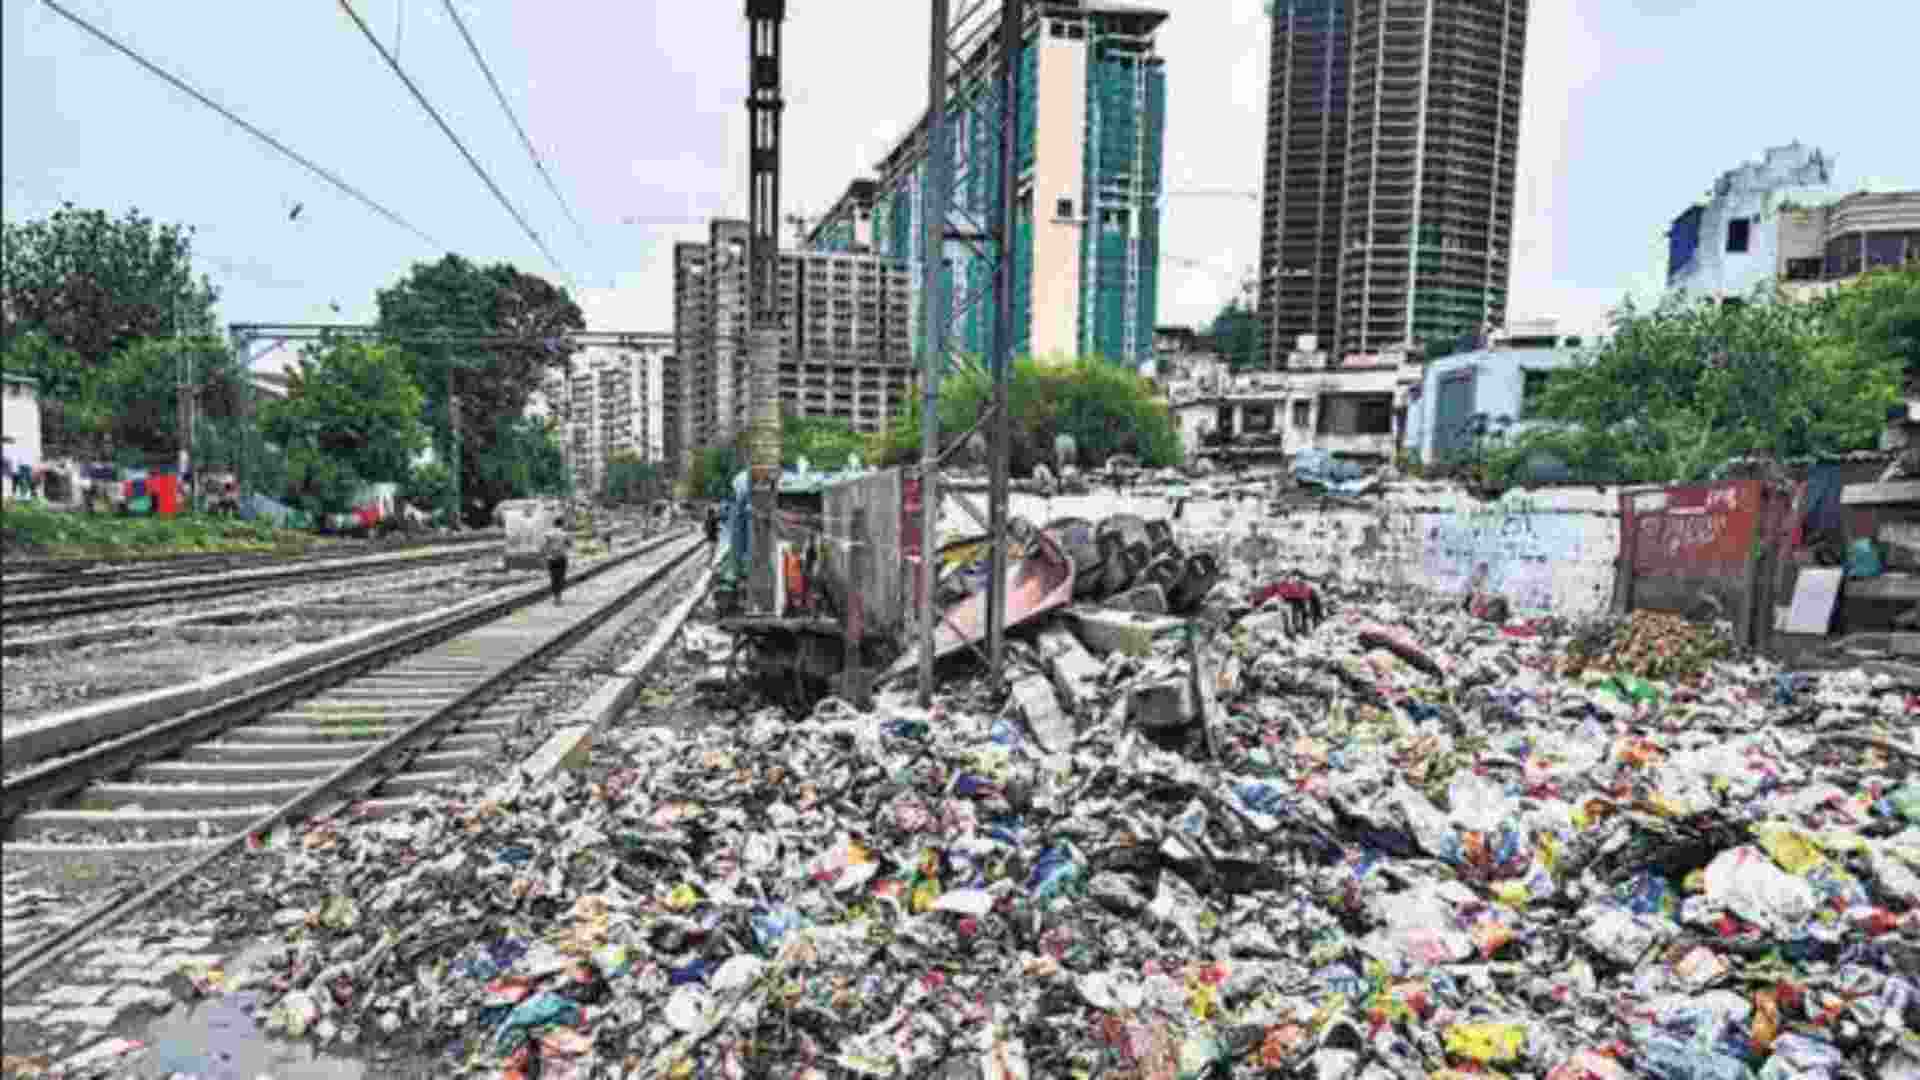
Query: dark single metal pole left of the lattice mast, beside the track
[{"left": 747, "top": 0, "right": 787, "bottom": 611}]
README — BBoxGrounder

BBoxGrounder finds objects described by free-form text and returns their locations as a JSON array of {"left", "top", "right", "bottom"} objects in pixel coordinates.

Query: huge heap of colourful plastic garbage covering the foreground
[{"left": 97, "top": 564, "right": 1920, "bottom": 1080}]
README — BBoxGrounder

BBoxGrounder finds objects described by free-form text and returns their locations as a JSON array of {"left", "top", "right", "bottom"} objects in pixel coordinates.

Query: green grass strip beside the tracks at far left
[{"left": 0, "top": 500, "right": 313, "bottom": 555}]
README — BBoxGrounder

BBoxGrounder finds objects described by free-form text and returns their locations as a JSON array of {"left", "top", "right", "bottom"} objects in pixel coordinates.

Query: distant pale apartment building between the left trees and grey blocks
[{"left": 541, "top": 346, "right": 674, "bottom": 492}]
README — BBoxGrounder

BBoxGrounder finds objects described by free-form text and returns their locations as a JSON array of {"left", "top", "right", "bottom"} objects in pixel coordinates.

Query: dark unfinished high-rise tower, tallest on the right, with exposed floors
[{"left": 1260, "top": 0, "right": 1526, "bottom": 367}]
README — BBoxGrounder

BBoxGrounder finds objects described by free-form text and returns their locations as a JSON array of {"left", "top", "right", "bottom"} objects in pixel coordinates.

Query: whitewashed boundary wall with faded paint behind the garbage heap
[{"left": 941, "top": 484, "right": 1620, "bottom": 617}]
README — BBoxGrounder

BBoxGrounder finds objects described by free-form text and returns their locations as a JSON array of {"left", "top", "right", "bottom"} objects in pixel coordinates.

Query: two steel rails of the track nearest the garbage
[{"left": 0, "top": 532, "right": 707, "bottom": 994}]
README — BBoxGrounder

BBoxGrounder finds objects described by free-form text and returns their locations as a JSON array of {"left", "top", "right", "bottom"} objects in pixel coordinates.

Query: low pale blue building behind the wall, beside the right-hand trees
[{"left": 1405, "top": 321, "right": 1580, "bottom": 463}]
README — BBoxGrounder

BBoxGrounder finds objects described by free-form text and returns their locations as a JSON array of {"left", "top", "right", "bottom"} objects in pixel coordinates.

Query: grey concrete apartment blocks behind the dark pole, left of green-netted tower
[{"left": 674, "top": 219, "right": 914, "bottom": 461}]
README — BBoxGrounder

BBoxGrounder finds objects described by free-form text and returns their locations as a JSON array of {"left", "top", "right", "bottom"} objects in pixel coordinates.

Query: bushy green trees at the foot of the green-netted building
[{"left": 879, "top": 357, "right": 1181, "bottom": 475}]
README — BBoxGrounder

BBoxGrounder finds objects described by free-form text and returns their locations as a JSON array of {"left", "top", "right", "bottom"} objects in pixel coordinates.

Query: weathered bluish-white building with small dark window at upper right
[{"left": 1667, "top": 142, "right": 1832, "bottom": 298}]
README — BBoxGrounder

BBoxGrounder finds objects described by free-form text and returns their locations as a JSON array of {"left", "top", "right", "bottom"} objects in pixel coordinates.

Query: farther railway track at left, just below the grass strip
[{"left": 0, "top": 542, "right": 499, "bottom": 626}]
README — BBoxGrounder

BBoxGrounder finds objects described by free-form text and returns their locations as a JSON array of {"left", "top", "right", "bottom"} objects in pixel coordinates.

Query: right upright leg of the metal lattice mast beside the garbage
[{"left": 987, "top": 0, "right": 1025, "bottom": 686}]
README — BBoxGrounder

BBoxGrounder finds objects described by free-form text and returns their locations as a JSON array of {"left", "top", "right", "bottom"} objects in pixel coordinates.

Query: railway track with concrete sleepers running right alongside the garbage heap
[{"left": 0, "top": 532, "right": 707, "bottom": 988}]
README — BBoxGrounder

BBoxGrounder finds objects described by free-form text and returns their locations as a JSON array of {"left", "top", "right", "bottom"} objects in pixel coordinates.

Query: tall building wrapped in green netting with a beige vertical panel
[{"left": 808, "top": 0, "right": 1167, "bottom": 369}]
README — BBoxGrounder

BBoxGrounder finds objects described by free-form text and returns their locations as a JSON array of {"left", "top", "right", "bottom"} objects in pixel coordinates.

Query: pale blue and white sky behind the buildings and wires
[{"left": 0, "top": 0, "right": 1920, "bottom": 368}]
